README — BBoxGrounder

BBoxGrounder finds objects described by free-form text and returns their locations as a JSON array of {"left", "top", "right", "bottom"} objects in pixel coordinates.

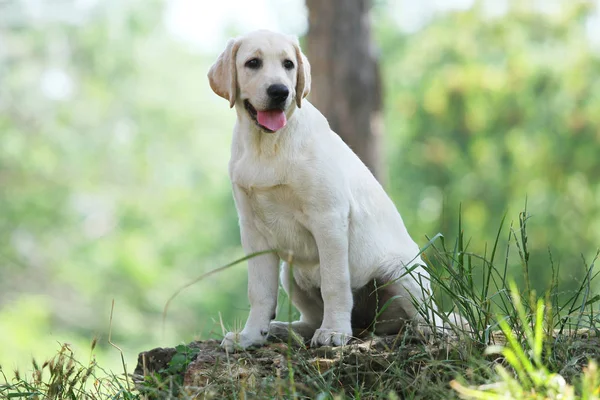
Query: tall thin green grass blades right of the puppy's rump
[{"left": 413, "top": 203, "right": 600, "bottom": 344}]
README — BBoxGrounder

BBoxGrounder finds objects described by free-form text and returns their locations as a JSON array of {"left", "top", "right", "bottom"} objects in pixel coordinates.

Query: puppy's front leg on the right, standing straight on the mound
[{"left": 311, "top": 212, "right": 353, "bottom": 346}]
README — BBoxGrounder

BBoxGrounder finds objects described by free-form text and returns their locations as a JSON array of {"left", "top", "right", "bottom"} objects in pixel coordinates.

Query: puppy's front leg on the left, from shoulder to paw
[{"left": 221, "top": 187, "right": 279, "bottom": 351}]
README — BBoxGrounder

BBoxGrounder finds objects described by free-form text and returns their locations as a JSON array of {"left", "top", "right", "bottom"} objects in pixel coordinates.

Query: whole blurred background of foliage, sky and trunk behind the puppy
[{"left": 0, "top": 0, "right": 600, "bottom": 369}]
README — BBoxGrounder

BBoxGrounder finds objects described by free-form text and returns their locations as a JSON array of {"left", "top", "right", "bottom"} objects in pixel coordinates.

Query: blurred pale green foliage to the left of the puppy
[{"left": 0, "top": 1, "right": 247, "bottom": 367}]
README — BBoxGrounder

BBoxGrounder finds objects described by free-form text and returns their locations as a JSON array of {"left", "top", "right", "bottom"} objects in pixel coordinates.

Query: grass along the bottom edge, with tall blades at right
[{"left": 0, "top": 210, "right": 600, "bottom": 400}]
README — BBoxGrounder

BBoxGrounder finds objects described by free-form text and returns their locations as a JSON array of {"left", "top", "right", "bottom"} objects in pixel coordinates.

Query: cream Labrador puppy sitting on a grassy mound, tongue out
[{"left": 208, "top": 30, "right": 443, "bottom": 351}]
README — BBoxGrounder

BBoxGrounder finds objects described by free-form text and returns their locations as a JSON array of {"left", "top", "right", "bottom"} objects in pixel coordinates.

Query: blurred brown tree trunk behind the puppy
[{"left": 306, "top": 0, "right": 382, "bottom": 179}]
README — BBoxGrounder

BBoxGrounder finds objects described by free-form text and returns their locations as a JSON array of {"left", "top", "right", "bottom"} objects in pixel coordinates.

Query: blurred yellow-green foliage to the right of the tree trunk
[{"left": 378, "top": 1, "right": 600, "bottom": 296}]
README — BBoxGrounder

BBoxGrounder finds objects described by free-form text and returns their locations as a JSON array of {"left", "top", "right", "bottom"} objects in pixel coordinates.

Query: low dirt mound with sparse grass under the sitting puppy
[{"left": 134, "top": 336, "right": 466, "bottom": 398}]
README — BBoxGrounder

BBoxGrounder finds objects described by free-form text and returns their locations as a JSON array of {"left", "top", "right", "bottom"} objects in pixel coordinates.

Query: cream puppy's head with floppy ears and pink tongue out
[{"left": 208, "top": 30, "right": 310, "bottom": 132}]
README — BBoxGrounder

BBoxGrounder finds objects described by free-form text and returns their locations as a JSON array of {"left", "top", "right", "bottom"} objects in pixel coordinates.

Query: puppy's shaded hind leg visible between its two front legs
[{"left": 269, "top": 263, "right": 323, "bottom": 341}]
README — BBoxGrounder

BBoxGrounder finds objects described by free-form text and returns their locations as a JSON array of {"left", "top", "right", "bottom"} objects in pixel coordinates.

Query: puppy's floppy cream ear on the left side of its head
[{"left": 208, "top": 39, "right": 241, "bottom": 107}]
